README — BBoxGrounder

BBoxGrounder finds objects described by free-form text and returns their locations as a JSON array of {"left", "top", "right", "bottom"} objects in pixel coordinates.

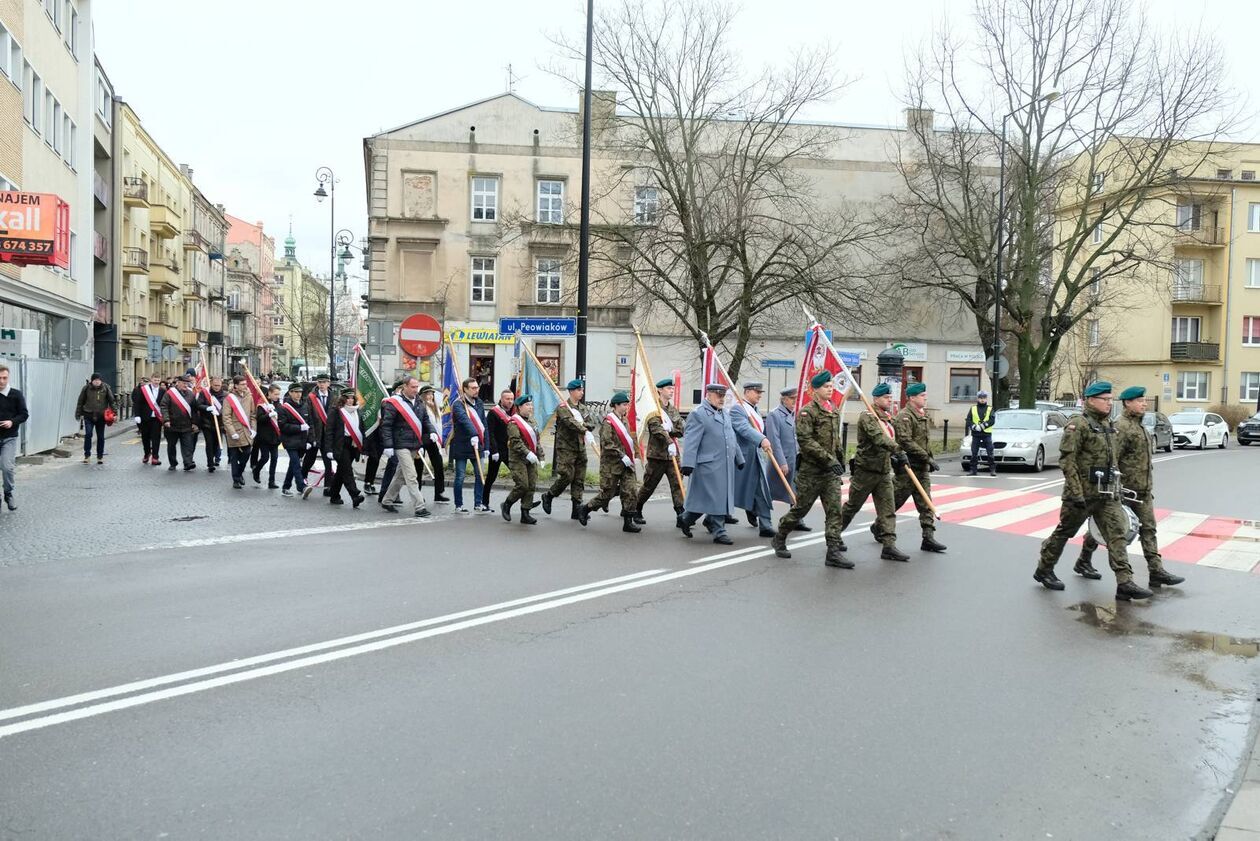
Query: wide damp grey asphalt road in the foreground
[{"left": 0, "top": 444, "right": 1260, "bottom": 840}]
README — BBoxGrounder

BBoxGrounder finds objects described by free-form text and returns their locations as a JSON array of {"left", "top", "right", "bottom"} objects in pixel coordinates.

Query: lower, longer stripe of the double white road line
[{"left": 0, "top": 556, "right": 752, "bottom": 739}]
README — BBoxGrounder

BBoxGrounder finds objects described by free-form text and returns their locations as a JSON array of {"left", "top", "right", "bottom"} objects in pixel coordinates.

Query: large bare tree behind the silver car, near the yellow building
[{"left": 891, "top": 0, "right": 1235, "bottom": 406}]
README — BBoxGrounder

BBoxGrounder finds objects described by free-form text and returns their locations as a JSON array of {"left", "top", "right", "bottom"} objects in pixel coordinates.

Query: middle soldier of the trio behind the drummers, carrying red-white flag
[{"left": 839, "top": 382, "right": 910, "bottom": 561}]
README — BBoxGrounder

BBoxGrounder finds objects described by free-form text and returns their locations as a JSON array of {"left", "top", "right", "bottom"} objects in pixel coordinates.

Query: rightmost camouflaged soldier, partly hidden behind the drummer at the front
[{"left": 1072, "top": 386, "right": 1186, "bottom": 588}]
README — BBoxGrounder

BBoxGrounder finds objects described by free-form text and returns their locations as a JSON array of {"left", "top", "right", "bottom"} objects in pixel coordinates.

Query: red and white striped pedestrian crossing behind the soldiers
[{"left": 831, "top": 485, "right": 1260, "bottom": 575}]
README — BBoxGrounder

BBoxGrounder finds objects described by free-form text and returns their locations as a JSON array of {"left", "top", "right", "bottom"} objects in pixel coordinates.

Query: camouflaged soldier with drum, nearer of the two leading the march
[{"left": 1032, "top": 382, "right": 1150, "bottom": 601}]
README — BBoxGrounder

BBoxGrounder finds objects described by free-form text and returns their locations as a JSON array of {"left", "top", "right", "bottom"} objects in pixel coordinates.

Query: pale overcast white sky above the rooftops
[{"left": 93, "top": 0, "right": 1260, "bottom": 282}]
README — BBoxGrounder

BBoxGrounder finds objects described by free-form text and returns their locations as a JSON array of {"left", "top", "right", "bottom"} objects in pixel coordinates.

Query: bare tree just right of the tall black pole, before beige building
[{"left": 558, "top": 0, "right": 887, "bottom": 376}]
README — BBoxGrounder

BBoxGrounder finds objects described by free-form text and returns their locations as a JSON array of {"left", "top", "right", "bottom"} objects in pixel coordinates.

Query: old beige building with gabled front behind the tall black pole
[{"left": 364, "top": 92, "right": 984, "bottom": 411}]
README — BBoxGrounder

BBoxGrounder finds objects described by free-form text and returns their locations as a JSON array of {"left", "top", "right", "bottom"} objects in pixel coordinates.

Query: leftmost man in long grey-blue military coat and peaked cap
[{"left": 677, "top": 383, "right": 745, "bottom": 546}]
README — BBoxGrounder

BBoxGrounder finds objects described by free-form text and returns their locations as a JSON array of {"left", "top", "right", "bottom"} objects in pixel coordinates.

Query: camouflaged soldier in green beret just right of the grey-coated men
[{"left": 770, "top": 371, "right": 853, "bottom": 570}]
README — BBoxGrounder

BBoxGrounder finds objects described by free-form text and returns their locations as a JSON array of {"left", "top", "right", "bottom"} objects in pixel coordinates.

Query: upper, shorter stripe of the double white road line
[{"left": 0, "top": 570, "right": 665, "bottom": 721}]
